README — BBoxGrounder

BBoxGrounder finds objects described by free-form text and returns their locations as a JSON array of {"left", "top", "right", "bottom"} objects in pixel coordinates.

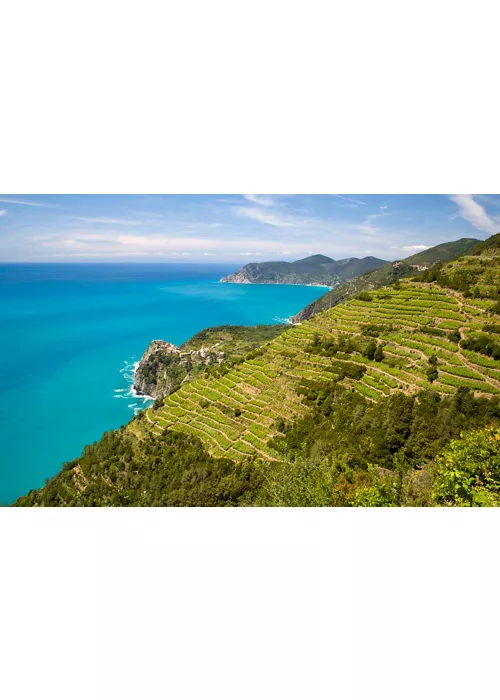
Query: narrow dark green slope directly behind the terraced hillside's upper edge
[{"left": 292, "top": 238, "right": 478, "bottom": 323}]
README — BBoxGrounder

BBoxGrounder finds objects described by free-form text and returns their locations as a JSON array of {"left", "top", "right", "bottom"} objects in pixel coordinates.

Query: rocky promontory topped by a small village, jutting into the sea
[{"left": 134, "top": 325, "right": 286, "bottom": 398}]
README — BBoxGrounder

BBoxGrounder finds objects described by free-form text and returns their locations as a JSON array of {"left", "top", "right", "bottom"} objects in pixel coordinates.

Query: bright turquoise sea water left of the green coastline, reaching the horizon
[{"left": 0, "top": 263, "right": 326, "bottom": 504}]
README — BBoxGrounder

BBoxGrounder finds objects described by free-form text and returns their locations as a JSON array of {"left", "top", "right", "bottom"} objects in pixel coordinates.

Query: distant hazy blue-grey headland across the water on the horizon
[{"left": 221, "top": 255, "right": 385, "bottom": 287}]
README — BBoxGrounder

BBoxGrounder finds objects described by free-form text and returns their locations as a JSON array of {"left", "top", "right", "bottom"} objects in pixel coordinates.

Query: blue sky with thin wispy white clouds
[{"left": 0, "top": 194, "right": 500, "bottom": 265}]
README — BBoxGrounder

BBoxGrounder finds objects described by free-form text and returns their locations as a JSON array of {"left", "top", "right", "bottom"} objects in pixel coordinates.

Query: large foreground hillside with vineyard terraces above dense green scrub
[{"left": 17, "top": 235, "right": 500, "bottom": 506}]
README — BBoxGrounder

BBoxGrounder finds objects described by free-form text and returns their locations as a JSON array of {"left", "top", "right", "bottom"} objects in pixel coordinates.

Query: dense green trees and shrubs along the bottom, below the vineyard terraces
[{"left": 17, "top": 382, "right": 500, "bottom": 506}]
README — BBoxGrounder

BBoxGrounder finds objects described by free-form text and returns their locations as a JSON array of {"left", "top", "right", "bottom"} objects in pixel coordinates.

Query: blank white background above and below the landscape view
[{"left": 0, "top": 0, "right": 499, "bottom": 700}]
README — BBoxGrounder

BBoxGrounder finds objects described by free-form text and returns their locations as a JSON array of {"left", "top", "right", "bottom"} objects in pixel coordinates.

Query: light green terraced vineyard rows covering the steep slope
[{"left": 145, "top": 272, "right": 500, "bottom": 460}]
